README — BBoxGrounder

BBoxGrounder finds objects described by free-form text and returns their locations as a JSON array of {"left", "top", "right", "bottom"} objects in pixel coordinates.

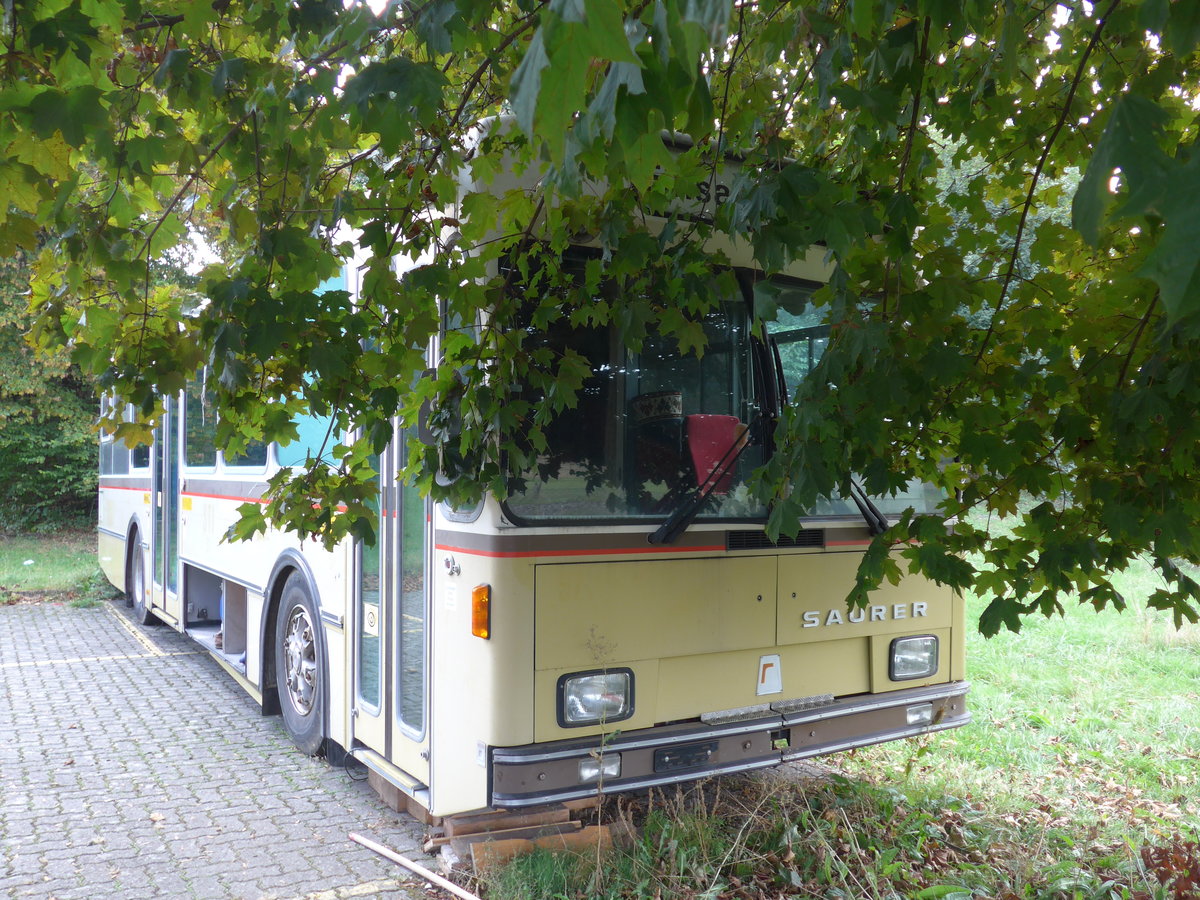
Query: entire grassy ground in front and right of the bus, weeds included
[{"left": 482, "top": 556, "right": 1200, "bottom": 900}]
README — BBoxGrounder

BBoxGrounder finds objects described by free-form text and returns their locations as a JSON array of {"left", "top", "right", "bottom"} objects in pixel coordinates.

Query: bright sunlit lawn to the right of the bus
[{"left": 842, "top": 570, "right": 1200, "bottom": 836}]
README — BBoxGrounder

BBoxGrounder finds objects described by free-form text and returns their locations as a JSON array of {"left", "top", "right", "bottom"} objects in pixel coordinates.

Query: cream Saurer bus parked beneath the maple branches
[{"left": 98, "top": 144, "right": 971, "bottom": 816}]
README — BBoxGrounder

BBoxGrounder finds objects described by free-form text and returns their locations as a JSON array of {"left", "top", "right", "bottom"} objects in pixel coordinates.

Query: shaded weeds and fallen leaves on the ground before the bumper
[{"left": 484, "top": 774, "right": 1198, "bottom": 900}]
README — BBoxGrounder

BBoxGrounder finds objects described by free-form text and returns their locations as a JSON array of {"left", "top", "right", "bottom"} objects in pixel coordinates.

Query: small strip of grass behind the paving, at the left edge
[{"left": 0, "top": 529, "right": 114, "bottom": 608}]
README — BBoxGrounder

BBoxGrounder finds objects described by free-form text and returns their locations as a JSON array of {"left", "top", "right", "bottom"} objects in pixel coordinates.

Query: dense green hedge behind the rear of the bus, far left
[{"left": 0, "top": 258, "right": 96, "bottom": 530}]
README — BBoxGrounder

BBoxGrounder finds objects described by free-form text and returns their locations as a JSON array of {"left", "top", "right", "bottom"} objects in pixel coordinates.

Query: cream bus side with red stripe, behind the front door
[{"left": 97, "top": 398, "right": 354, "bottom": 758}]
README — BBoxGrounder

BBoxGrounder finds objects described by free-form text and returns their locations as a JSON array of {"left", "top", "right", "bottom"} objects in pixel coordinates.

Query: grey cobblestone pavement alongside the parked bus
[{"left": 0, "top": 604, "right": 433, "bottom": 900}]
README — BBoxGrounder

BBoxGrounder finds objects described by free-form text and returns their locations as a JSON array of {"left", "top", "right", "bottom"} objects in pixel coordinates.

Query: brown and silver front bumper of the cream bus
[{"left": 491, "top": 682, "right": 971, "bottom": 808}]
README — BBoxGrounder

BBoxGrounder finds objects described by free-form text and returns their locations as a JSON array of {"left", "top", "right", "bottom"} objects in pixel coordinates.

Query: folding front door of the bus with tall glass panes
[{"left": 352, "top": 433, "right": 431, "bottom": 785}]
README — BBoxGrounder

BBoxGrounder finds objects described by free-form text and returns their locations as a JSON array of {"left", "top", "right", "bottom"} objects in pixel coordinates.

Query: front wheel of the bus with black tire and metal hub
[{"left": 275, "top": 572, "right": 325, "bottom": 756}]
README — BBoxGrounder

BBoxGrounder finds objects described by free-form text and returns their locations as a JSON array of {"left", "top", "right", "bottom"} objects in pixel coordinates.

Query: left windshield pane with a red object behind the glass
[{"left": 508, "top": 264, "right": 766, "bottom": 523}]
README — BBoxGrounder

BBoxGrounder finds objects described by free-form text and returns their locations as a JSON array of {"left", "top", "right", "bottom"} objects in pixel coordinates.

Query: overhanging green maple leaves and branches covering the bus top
[{"left": 7, "top": 0, "right": 1200, "bottom": 632}]
